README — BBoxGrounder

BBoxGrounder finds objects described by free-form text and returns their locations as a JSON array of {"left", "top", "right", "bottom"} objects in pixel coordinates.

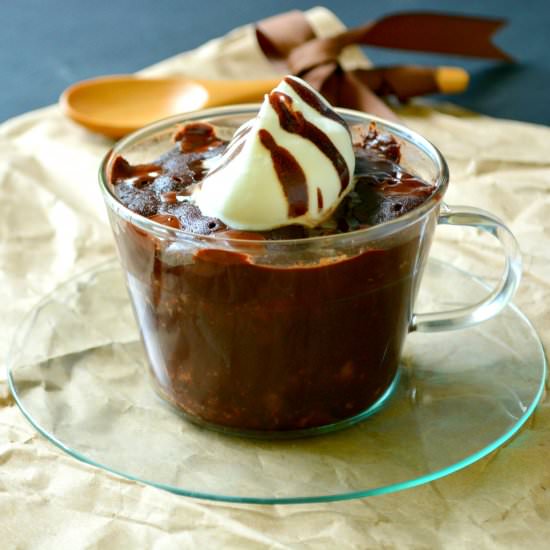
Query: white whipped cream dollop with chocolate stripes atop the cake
[{"left": 193, "top": 76, "right": 355, "bottom": 231}]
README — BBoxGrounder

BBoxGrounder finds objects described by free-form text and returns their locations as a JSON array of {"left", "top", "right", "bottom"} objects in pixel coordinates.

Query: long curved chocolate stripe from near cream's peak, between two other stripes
[{"left": 269, "top": 92, "right": 350, "bottom": 194}]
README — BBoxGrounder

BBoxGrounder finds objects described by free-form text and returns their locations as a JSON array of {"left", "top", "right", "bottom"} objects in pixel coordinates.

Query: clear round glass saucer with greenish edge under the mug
[{"left": 8, "top": 260, "right": 546, "bottom": 504}]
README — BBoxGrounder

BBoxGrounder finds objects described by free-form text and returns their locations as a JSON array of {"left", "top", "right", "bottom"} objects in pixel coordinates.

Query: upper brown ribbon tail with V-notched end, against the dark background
[{"left": 360, "top": 12, "right": 513, "bottom": 61}]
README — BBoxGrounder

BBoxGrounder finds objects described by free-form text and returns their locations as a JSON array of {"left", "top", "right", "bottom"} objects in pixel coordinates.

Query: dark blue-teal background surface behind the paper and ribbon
[{"left": 0, "top": 0, "right": 550, "bottom": 124}]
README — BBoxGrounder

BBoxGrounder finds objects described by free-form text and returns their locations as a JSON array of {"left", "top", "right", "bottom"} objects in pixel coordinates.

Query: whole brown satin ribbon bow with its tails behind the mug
[{"left": 256, "top": 10, "right": 512, "bottom": 119}]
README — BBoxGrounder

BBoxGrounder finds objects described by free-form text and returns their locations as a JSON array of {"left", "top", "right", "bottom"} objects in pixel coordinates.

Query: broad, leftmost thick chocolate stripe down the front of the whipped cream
[{"left": 258, "top": 128, "right": 308, "bottom": 218}]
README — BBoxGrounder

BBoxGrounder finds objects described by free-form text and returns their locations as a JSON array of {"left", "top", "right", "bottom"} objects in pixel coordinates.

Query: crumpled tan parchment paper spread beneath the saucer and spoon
[{"left": 0, "top": 8, "right": 550, "bottom": 549}]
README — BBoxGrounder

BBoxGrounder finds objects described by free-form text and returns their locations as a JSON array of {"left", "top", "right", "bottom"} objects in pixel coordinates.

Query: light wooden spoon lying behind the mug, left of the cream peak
[{"left": 59, "top": 75, "right": 281, "bottom": 138}]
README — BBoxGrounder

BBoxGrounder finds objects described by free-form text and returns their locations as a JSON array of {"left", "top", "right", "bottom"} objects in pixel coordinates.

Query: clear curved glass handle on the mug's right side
[{"left": 409, "top": 205, "right": 521, "bottom": 332}]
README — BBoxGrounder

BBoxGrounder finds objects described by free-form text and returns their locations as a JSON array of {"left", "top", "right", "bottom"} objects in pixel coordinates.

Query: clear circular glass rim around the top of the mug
[{"left": 99, "top": 103, "right": 449, "bottom": 246}]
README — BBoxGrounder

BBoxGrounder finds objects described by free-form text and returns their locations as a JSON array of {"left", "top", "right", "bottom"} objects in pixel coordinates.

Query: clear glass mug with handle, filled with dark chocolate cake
[{"left": 100, "top": 106, "right": 521, "bottom": 437}]
